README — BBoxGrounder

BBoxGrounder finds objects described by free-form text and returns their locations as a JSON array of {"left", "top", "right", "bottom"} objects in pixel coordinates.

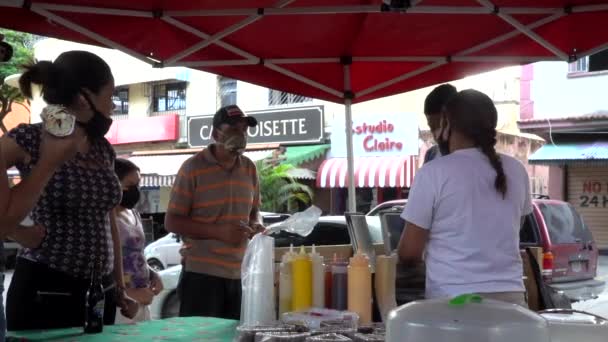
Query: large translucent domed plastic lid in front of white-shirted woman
[{"left": 386, "top": 295, "right": 551, "bottom": 342}]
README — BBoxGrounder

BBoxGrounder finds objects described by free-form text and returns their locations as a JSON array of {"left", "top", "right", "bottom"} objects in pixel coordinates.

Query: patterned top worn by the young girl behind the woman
[{"left": 116, "top": 209, "right": 150, "bottom": 288}]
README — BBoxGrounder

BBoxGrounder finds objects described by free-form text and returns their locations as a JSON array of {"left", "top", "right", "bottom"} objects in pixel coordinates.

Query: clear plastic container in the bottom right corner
[{"left": 540, "top": 310, "right": 608, "bottom": 342}]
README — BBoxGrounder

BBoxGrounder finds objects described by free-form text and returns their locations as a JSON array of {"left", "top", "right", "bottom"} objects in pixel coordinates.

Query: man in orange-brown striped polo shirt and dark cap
[{"left": 165, "top": 105, "right": 264, "bottom": 319}]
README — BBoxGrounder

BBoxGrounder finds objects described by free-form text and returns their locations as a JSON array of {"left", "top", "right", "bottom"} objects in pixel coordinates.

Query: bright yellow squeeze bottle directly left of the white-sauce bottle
[{"left": 291, "top": 246, "right": 312, "bottom": 311}]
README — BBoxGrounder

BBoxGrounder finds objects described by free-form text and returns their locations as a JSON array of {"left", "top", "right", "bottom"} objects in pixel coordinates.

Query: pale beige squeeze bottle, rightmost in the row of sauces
[{"left": 374, "top": 254, "right": 397, "bottom": 322}]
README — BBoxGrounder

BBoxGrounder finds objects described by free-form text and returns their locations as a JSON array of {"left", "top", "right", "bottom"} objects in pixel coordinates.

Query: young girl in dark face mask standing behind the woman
[{"left": 114, "top": 158, "right": 163, "bottom": 324}]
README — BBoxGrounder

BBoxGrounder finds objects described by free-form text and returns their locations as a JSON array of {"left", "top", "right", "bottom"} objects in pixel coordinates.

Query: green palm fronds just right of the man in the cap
[{"left": 256, "top": 160, "right": 313, "bottom": 212}]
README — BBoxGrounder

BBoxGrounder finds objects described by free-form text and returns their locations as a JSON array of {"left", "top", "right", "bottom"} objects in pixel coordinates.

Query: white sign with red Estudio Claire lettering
[{"left": 331, "top": 113, "right": 418, "bottom": 157}]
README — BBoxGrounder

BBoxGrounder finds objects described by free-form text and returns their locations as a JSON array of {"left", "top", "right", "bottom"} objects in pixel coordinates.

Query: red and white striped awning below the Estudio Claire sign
[{"left": 317, "top": 156, "right": 417, "bottom": 188}]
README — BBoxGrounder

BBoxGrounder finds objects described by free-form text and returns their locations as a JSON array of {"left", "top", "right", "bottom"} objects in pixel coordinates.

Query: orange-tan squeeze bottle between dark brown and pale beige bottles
[{"left": 348, "top": 252, "right": 372, "bottom": 324}]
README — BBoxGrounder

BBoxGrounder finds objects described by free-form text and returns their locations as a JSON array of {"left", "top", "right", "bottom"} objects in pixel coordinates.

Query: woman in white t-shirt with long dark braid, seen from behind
[{"left": 398, "top": 89, "right": 532, "bottom": 306}]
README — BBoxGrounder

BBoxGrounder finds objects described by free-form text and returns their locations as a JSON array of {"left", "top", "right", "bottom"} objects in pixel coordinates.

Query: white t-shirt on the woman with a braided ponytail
[{"left": 401, "top": 148, "right": 532, "bottom": 298}]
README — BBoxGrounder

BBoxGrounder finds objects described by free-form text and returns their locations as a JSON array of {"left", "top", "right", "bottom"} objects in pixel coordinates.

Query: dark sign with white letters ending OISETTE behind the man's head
[{"left": 188, "top": 106, "right": 323, "bottom": 147}]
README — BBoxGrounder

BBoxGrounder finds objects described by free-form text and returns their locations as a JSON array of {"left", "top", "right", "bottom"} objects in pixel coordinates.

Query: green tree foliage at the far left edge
[{"left": 0, "top": 29, "right": 36, "bottom": 133}]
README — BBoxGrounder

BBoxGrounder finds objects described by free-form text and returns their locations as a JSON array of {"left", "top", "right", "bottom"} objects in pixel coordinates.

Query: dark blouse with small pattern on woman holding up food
[{"left": 8, "top": 124, "right": 122, "bottom": 278}]
